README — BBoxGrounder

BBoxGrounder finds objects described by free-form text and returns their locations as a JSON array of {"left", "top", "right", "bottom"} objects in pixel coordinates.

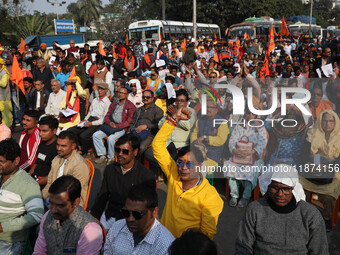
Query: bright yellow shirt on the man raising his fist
[{"left": 152, "top": 122, "right": 223, "bottom": 239}]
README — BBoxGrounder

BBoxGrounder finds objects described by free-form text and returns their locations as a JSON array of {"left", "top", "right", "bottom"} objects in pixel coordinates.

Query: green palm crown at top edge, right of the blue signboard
[{"left": 77, "top": 0, "right": 103, "bottom": 26}]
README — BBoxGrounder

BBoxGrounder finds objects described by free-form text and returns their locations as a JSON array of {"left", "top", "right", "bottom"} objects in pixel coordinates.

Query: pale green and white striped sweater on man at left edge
[{"left": 0, "top": 169, "right": 44, "bottom": 242}]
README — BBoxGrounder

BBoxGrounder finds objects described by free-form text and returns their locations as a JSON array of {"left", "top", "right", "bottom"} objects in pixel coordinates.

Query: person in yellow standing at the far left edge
[{"left": 0, "top": 58, "right": 13, "bottom": 127}]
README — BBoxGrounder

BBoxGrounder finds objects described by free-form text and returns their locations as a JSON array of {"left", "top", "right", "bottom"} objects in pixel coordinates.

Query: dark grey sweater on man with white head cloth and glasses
[{"left": 236, "top": 198, "right": 328, "bottom": 255}]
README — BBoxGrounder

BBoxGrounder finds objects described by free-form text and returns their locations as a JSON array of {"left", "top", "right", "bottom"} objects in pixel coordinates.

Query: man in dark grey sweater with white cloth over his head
[{"left": 236, "top": 164, "right": 328, "bottom": 254}]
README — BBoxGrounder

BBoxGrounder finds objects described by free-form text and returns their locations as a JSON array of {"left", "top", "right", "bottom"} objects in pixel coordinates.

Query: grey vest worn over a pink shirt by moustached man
[{"left": 43, "top": 206, "right": 97, "bottom": 255}]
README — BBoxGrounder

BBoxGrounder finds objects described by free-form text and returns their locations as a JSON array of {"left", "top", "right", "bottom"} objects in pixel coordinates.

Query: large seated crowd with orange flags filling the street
[{"left": 0, "top": 33, "right": 340, "bottom": 254}]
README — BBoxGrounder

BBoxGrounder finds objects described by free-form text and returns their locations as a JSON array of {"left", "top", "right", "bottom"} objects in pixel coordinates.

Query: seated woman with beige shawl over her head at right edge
[{"left": 300, "top": 110, "right": 340, "bottom": 231}]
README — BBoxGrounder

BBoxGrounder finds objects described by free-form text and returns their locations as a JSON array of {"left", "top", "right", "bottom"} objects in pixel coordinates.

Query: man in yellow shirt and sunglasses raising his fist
[{"left": 152, "top": 108, "right": 223, "bottom": 239}]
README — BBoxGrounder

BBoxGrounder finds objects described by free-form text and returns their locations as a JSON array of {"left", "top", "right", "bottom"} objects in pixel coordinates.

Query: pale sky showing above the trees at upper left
[{"left": 25, "top": 0, "right": 109, "bottom": 14}]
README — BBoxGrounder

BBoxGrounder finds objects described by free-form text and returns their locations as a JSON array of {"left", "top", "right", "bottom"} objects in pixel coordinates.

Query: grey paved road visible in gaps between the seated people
[{"left": 13, "top": 127, "right": 340, "bottom": 255}]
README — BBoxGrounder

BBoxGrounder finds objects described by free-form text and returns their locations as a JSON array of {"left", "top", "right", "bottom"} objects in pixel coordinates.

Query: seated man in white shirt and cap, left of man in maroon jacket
[{"left": 69, "top": 82, "right": 111, "bottom": 155}]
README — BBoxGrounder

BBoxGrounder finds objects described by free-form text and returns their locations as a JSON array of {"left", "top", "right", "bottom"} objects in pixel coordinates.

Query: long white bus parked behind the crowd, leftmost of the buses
[{"left": 129, "top": 20, "right": 221, "bottom": 43}]
